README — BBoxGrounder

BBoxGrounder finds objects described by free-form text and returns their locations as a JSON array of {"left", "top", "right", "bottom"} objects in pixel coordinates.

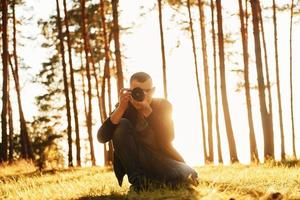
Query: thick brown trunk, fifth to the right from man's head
[{"left": 216, "top": 0, "right": 238, "bottom": 162}]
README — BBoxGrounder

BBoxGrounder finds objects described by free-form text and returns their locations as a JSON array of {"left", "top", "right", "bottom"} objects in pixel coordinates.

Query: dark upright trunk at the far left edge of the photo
[{"left": 0, "top": 0, "right": 8, "bottom": 162}]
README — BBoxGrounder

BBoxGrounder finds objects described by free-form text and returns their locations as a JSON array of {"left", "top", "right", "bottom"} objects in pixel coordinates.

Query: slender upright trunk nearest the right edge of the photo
[{"left": 290, "top": 0, "right": 296, "bottom": 158}]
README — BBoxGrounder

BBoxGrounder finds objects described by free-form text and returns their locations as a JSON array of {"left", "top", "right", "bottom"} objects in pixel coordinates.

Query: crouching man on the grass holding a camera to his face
[{"left": 97, "top": 72, "right": 198, "bottom": 191}]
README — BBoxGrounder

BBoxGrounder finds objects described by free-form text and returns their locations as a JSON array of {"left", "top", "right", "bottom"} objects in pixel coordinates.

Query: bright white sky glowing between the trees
[{"left": 2, "top": 0, "right": 300, "bottom": 165}]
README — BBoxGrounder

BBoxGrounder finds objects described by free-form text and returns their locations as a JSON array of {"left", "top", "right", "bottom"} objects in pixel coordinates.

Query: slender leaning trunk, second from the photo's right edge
[{"left": 273, "top": 0, "right": 285, "bottom": 160}]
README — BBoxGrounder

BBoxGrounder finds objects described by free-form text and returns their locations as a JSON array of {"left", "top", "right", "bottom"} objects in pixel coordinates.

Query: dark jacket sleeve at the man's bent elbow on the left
[{"left": 97, "top": 117, "right": 117, "bottom": 143}]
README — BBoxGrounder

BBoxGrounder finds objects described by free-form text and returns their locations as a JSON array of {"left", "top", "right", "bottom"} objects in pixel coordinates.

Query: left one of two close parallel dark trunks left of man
[{"left": 56, "top": 0, "right": 73, "bottom": 167}]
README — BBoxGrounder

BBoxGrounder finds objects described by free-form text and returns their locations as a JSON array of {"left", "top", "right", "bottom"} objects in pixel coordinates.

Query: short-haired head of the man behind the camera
[{"left": 130, "top": 72, "right": 155, "bottom": 104}]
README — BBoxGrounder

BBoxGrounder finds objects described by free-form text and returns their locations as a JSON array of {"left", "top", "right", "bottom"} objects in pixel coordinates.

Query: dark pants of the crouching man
[{"left": 113, "top": 118, "right": 197, "bottom": 189}]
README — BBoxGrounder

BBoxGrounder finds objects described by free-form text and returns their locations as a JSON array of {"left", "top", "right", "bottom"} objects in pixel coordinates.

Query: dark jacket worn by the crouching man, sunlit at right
[{"left": 97, "top": 99, "right": 184, "bottom": 186}]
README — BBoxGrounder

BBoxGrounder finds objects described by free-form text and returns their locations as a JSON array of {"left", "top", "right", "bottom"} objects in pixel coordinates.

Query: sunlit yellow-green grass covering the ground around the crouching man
[{"left": 0, "top": 162, "right": 300, "bottom": 200}]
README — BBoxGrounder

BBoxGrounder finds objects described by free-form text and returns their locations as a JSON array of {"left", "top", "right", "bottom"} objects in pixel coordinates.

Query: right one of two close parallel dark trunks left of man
[{"left": 63, "top": 0, "right": 81, "bottom": 166}]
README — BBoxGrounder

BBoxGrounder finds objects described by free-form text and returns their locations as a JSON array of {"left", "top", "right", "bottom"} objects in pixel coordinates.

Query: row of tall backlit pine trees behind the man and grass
[{"left": 0, "top": 0, "right": 299, "bottom": 168}]
